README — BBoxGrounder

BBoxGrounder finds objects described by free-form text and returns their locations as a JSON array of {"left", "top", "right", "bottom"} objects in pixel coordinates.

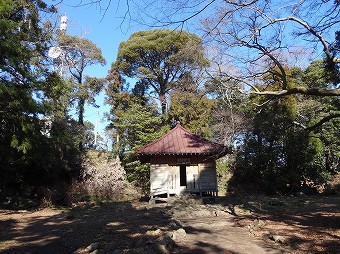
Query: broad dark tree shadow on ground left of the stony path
[{"left": 0, "top": 202, "right": 175, "bottom": 254}]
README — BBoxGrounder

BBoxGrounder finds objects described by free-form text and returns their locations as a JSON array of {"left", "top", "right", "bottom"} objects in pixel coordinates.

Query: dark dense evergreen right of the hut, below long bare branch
[{"left": 234, "top": 65, "right": 337, "bottom": 193}]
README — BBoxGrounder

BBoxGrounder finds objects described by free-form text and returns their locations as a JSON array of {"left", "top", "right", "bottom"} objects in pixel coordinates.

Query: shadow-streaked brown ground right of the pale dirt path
[{"left": 219, "top": 195, "right": 340, "bottom": 253}]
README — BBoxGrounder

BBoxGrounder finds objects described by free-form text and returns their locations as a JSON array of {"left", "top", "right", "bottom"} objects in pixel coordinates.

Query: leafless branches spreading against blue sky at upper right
[{"left": 107, "top": 0, "right": 340, "bottom": 125}]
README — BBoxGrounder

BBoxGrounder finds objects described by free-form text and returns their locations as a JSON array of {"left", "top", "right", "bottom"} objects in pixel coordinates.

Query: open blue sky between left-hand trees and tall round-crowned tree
[{"left": 45, "top": 0, "right": 143, "bottom": 137}]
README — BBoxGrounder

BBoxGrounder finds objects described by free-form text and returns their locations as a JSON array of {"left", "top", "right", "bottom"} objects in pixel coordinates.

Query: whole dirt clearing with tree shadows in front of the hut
[{"left": 0, "top": 195, "right": 340, "bottom": 254}]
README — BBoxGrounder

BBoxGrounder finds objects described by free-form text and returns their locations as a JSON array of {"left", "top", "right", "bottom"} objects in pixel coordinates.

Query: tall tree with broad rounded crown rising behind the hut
[{"left": 112, "top": 29, "right": 208, "bottom": 114}]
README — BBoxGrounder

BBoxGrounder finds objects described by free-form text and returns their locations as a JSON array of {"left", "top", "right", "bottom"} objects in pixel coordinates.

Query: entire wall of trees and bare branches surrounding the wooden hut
[{"left": 0, "top": 0, "right": 340, "bottom": 206}]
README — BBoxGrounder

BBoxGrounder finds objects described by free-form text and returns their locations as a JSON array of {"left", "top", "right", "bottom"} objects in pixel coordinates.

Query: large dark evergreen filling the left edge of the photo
[{"left": 0, "top": 0, "right": 79, "bottom": 199}]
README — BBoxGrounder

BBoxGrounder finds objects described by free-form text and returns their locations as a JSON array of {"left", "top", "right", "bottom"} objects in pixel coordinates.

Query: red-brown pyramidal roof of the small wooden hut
[{"left": 137, "top": 123, "right": 228, "bottom": 157}]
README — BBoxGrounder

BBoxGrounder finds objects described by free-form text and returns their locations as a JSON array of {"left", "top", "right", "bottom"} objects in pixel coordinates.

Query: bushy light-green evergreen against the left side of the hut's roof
[{"left": 112, "top": 92, "right": 165, "bottom": 189}]
